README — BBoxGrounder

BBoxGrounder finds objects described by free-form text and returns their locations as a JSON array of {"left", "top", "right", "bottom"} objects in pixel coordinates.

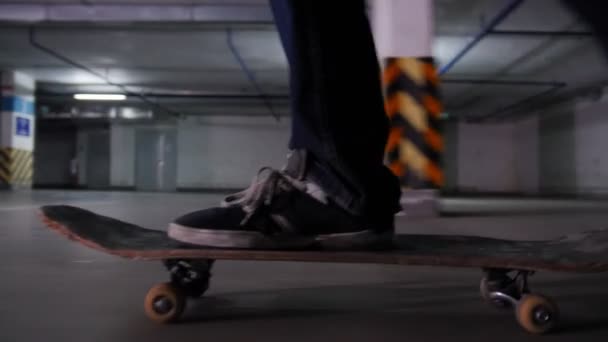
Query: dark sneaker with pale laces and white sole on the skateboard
[{"left": 168, "top": 168, "right": 394, "bottom": 249}]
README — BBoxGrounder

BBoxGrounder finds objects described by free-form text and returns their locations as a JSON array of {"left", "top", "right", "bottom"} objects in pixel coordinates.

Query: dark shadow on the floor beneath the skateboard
[{"left": 175, "top": 276, "right": 608, "bottom": 335}]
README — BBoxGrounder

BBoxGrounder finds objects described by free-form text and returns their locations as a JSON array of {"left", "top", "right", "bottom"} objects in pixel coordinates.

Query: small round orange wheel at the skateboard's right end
[{"left": 515, "top": 294, "right": 559, "bottom": 334}]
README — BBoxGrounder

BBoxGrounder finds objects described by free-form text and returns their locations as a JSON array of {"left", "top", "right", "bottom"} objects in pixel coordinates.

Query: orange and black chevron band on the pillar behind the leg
[{"left": 382, "top": 58, "right": 444, "bottom": 189}]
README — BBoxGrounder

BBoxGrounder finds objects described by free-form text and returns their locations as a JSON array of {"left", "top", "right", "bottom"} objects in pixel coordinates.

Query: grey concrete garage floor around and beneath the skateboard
[{"left": 0, "top": 191, "right": 608, "bottom": 342}]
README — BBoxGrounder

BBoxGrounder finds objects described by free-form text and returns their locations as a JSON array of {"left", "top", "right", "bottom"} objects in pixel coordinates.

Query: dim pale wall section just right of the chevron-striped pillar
[{"left": 443, "top": 117, "right": 539, "bottom": 194}]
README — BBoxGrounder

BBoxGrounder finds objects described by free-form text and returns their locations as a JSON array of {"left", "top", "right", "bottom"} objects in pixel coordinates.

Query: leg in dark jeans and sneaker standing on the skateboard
[{"left": 168, "top": 0, "right": 400, "bottom": 248}]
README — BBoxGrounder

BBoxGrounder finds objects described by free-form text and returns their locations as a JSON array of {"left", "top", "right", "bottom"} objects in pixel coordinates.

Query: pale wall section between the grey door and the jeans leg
[{"left": 177, "top": 116, "right": 290, "bottom": 189}]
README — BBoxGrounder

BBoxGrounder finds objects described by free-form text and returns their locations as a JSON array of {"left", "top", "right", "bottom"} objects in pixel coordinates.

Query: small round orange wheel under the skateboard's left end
[{"left": 144, "top": 283, "right": 186, "bottom": 323}]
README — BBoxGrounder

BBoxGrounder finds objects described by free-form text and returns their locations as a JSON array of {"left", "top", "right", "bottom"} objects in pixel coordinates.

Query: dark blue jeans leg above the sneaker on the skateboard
[{"left": 270, "top": 0, "right": 401, "bottom": 219}]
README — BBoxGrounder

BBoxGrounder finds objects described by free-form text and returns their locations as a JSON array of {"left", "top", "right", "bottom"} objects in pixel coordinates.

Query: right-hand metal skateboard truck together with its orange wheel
[{"left": 479, "top": 268, "right": 559, "bottom": 334}]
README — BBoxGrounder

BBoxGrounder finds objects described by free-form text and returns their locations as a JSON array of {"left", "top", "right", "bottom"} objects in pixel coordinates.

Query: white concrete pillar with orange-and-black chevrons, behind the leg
[{"left": 372, "top": 0, "right": 444, "bottom": 216}]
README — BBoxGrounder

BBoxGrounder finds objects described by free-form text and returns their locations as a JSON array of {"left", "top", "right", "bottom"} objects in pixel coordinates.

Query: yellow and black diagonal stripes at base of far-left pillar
[{"left": 0, "top": 147, "right": 33, "bottom": 187}]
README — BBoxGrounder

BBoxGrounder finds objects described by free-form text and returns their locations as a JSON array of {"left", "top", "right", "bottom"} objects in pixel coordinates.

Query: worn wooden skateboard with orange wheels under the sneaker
[{"left": 40, "top": 206, "right": 608, "bottom": 334}]
